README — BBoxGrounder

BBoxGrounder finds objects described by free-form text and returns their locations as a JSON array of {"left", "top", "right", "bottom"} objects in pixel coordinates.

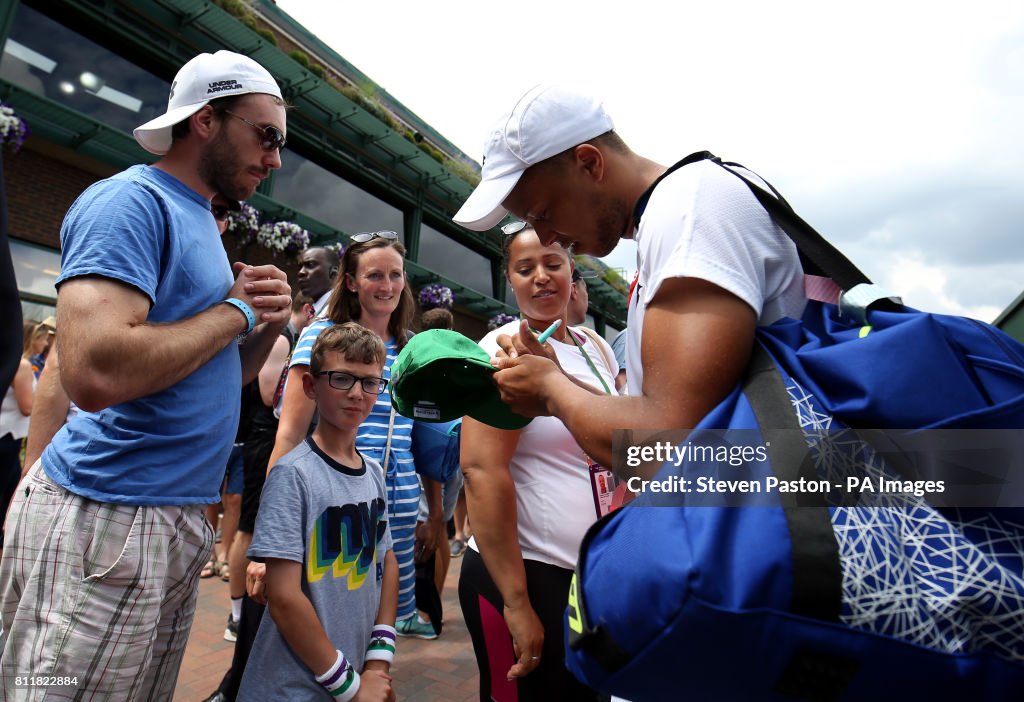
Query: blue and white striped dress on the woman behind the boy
[{"left": 290, "top": 319, "right": 420, "bottom": 619}]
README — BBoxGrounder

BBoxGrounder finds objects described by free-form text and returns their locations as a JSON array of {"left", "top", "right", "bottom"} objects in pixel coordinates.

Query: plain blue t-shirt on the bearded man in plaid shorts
[{"left": 43, "top": 166, "right": 242, "bottom": 504}]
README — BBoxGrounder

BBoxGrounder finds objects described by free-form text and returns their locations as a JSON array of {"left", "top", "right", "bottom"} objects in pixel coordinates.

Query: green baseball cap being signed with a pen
[{"left": 391, "top": 330, "right": 529, "bottom": 429}]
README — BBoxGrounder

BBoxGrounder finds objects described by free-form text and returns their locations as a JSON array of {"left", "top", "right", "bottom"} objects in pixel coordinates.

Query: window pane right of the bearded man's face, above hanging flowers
[{"left": 273, "top": 149, "right": 406, "bottom": 243}]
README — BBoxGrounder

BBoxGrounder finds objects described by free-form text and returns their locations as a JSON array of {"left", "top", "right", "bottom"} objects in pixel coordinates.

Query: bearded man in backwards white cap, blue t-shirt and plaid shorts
[{"left": 0, "top": 51, "right": 291, "bottom": 700}]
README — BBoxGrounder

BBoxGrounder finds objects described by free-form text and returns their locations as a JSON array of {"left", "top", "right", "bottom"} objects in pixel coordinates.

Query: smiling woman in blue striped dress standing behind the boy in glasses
[{"left": 260, "top": 231, "right": 436, "bottom": 639}]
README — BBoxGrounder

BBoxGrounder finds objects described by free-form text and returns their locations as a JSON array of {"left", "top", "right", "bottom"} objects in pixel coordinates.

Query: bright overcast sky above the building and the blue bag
[{"left": 278, "top": 0, "right": 1024, "bottom": 321}]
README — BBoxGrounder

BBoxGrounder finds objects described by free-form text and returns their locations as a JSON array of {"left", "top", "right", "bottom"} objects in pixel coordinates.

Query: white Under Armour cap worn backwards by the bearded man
[{"left": 132, "top": 49, "right": 283, "bottom": 156}]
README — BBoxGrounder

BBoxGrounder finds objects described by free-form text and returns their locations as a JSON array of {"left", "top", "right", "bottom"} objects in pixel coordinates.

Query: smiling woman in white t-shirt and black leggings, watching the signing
[{"left": 459, "top": 222, "right": 614, "bottom": 702}]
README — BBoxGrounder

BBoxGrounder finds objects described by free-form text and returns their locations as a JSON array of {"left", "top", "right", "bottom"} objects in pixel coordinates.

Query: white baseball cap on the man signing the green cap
[{"left": 452, "top": 84, "right": 614, "bottom": 231}]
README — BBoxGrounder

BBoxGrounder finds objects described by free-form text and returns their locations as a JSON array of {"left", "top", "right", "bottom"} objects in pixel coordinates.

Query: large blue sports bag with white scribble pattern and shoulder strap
[{"left": 565, "top": 152, "right": 1024, "bottom": 702}]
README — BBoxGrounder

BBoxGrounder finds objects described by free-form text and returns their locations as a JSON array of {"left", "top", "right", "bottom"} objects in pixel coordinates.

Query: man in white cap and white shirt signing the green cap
[{"left": 454, "top": 85, "right": 806, "bottom": 478}]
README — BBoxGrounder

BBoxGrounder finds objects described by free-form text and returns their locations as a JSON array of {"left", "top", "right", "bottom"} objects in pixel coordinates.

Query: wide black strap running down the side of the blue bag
[{"left": 742, "top": 343, "right": 843, "bottom": 621}]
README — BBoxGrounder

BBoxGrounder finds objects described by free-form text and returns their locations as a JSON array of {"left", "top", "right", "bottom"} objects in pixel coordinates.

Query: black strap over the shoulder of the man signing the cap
[{"left": 633, "top": 151, "right": 899, "bottom": 310}]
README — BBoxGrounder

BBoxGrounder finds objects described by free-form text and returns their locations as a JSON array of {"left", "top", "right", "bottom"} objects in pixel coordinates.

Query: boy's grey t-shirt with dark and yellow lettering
[{"left": 239, "top": 437, "right": 391, "bottom": 700}]
